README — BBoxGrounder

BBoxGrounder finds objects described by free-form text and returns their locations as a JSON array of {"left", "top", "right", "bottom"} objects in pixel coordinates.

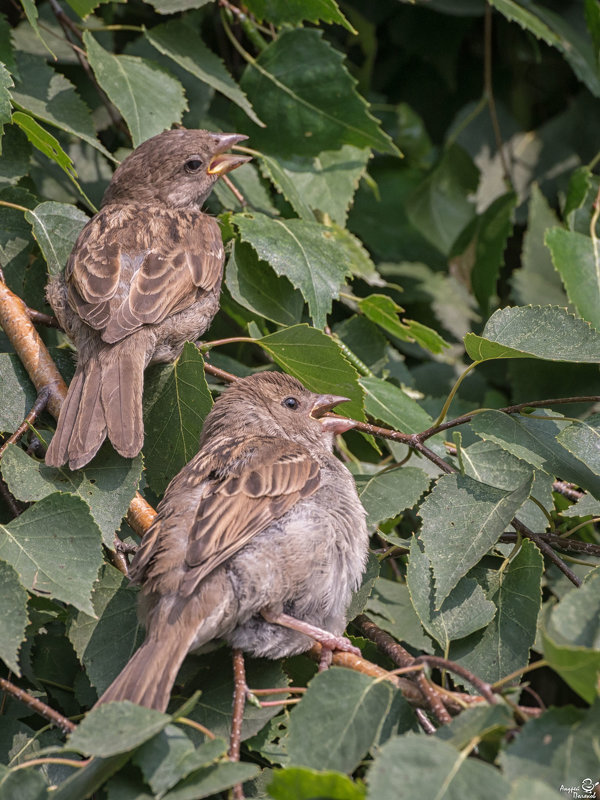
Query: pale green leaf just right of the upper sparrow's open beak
[{"left": 261, "top": 145, "right": 370, "bottom": 226}]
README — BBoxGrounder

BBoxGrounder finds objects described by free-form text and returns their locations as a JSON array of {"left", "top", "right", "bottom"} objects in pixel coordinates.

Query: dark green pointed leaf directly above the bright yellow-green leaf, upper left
[{"left": 12, "top": 52, "right": 114, "bottom": 160}]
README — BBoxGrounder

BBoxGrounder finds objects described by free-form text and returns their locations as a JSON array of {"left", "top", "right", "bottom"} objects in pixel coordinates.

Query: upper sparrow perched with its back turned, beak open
[{"left": 46, "top": 129, "right": 249, "bottom": 469}]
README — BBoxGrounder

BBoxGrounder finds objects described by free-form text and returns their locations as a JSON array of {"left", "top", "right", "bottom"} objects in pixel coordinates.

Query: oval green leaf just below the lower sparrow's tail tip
[{"left": 68, "top": 700, "right": 171, "bottom": 758}]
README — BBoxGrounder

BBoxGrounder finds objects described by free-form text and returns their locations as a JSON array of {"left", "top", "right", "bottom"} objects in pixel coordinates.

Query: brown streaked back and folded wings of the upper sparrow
[{"left": 65, "top": 205, "right": 224, "bottom": 343}]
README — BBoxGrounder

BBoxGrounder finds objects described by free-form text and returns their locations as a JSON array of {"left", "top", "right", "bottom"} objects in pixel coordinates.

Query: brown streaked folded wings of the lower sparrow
[{"left": 130, "top": 438, "right": 320, "bottom": 595}]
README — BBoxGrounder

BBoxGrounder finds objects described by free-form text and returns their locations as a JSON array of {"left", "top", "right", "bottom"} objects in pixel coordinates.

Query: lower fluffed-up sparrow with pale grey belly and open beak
[{"left": 99, "top": 372, "right": 368, "bottom": 710}]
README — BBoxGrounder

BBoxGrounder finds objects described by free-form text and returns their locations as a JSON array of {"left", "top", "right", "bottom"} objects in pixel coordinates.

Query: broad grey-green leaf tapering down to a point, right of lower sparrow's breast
[{"left": 419, "top": 474, "right": 533, "bottom": 610}]
